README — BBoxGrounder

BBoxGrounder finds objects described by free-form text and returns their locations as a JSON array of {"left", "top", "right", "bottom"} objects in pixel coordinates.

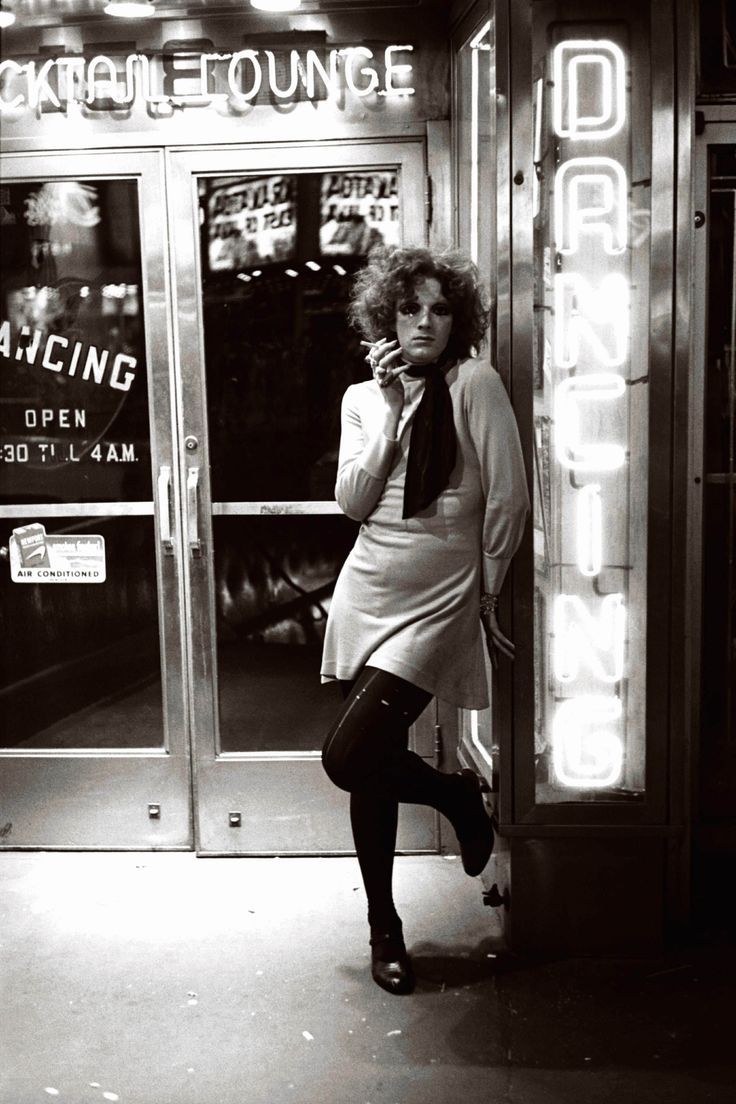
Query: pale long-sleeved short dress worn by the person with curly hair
[{"left": 322, "top": 359, "right": 529, "bottom": 709}]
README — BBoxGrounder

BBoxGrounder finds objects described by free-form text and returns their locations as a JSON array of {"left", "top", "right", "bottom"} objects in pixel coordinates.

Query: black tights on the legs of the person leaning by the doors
[{"left": 322, "top": 667, "right": 460, "bottom": 928}]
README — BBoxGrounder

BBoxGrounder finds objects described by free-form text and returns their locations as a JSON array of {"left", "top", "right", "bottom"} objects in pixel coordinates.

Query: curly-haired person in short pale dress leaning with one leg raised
[{"left": 321, "top": 248, "right": 529, "bottom": 994}]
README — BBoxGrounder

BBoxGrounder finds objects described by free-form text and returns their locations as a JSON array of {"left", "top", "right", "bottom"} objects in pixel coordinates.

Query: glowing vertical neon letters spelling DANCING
[{"left": 552, "top": 39, "right": 630, "bottom": 789}]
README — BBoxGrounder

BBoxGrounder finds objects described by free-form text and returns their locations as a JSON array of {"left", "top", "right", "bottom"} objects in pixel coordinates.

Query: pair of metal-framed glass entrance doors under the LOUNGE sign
[{"left": 0, "top": 141, "right": 437, "bottom": 853}]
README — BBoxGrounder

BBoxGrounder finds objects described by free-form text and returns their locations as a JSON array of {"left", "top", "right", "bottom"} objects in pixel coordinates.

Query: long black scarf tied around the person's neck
[{"left": 402, "top": 362, "right": 457, "bottom": 518}]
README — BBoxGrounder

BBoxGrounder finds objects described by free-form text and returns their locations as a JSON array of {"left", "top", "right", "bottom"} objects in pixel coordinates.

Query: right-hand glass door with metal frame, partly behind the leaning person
[{"left": 170, "top": 142, "right": 436, "bottom": 853}]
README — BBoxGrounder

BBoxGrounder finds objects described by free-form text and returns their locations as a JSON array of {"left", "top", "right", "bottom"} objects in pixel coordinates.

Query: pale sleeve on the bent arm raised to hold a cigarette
[{"left": 334, "top": 384, "right": 396, "bottom": 521}]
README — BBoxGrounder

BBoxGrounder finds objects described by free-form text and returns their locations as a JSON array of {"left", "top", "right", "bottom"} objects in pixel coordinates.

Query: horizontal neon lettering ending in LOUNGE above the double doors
[{"left": 0, "top": 45, "right": 415, "bottom": 114}]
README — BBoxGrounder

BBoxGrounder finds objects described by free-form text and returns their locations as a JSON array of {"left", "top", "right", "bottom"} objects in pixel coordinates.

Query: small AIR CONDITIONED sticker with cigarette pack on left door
[{"left": 10, "top": 522, "right": 106, "bottom": 583}]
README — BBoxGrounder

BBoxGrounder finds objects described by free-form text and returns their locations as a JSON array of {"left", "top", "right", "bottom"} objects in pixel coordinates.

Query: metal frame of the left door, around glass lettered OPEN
[{"left": 0, "top": 149, "right": 192, "bottom": 850}]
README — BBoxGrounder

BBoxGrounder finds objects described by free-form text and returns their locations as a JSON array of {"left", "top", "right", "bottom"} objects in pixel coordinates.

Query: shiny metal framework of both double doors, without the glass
[{"left": 0, "top": 138, "right": 441, "bottom": 854}]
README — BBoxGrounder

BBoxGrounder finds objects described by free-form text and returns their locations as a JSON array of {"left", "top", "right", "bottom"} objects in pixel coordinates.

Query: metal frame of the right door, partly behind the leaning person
[{"left": 166, "top": 138, "right": 436, "bottom": 854}]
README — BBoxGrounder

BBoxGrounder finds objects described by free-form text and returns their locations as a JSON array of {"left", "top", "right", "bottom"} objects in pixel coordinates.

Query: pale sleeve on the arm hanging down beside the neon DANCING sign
[{"left": 466, "top": 361, "right": 530, "bottom": 594}]
